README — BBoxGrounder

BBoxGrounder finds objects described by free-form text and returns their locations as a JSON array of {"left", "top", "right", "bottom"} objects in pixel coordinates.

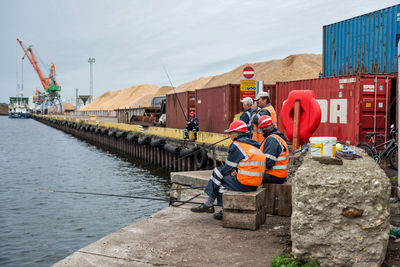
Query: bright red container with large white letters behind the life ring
[{"left": 276, "top": 74, "right": 396, "bottom": 145}]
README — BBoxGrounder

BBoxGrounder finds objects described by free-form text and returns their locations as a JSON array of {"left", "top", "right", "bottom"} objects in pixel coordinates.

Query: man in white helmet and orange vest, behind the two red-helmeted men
[{"left": 252, "top": 92, "right": 277, "bottom": 144}]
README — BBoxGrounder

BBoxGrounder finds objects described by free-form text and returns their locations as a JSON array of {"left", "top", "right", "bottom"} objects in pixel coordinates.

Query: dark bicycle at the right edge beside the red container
[{"left": 358, "top": 124, "right": 398, "bottom": 170}]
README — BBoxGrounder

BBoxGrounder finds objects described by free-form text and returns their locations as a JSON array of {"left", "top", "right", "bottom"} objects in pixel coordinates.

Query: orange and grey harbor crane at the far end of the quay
[{"left": 17, "top": 38, "right": 64, "bottom": 112}]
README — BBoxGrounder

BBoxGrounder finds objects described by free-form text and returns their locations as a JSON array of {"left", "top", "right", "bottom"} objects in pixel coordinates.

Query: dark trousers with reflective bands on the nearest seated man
[{"left": 204, "top": 167, "right": 258, "bottom": 206}]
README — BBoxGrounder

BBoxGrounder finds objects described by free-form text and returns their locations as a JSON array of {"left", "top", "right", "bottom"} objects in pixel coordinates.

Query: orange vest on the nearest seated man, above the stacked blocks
[{"left": 233, "top": 141, "right": 266, "bottom": 186}]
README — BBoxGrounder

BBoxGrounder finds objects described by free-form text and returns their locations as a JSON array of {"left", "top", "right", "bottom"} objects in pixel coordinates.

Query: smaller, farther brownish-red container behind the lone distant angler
[{"left": 165, "top": 91, "right": 196, "bottom": 129}]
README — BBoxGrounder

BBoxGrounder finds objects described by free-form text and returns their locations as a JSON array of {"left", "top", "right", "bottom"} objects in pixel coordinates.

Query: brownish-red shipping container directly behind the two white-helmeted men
[{"left": 196, "top": 84, "right": 275, "bottom": 133}]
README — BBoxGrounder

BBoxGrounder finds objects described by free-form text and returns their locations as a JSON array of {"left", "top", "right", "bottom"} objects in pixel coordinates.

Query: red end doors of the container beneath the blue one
[{"left": 360, "top": 75, "right": 391, "bottom": 143}]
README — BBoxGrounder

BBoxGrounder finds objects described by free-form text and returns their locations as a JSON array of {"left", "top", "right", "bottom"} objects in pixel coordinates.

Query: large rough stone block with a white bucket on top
[{"left": 291, "top": 150, "right": 391, "bottom": 267}]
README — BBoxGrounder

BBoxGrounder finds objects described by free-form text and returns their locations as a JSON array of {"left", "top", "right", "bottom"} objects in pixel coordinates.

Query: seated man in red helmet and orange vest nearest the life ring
[{"left": 258, "top": 115, "right": 289, "bottom": 184}]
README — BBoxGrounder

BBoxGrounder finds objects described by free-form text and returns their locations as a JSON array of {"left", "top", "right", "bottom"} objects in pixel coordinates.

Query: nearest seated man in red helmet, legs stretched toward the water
[{"left": 191, "top": 120, "right": 265, "bottom": 220}]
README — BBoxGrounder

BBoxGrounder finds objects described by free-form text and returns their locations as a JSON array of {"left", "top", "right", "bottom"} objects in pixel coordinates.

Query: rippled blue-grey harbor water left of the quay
[{"left": 0, "top": 116, "right": 170, "bottom": 266}]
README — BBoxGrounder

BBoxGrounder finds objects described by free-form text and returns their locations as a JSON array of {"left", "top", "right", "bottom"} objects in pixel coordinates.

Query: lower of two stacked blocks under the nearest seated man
[{"left": 222, "top": 207, "right": 266, "bottom": 230}]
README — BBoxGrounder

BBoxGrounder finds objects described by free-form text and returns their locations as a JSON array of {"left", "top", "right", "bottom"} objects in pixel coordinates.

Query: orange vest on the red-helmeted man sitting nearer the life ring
[{"left": 260, "top": 134, "right": 289, "bottom": 178}]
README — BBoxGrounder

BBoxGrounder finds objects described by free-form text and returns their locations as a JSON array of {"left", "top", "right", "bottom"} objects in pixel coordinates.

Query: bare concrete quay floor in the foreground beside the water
[{"left": 54, "top": 171, "right": 290, "bottom": 266}]
